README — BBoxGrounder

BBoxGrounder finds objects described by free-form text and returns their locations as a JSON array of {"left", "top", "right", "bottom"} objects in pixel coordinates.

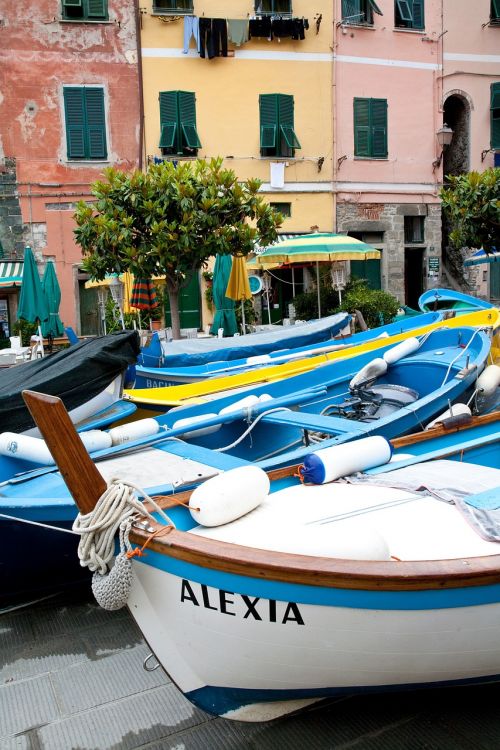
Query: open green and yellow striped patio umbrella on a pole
[{"left": 251, "top": 232, "right": 380, "bottom": 317}]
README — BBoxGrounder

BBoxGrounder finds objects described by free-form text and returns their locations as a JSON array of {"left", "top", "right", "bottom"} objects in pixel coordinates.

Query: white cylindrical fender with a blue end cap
[{"left": 300, "top": 435, "right": 392, "bottom": 484}]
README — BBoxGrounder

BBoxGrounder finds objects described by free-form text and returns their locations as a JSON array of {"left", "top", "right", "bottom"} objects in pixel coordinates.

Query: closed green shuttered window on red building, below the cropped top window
[{"left": 63, "top": 86, "right": 108, "bottom": 159}]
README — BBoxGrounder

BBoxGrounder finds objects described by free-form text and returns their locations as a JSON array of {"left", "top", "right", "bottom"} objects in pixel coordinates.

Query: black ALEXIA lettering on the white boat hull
[{"left": 181, "top": 578, "right": 304, "bottom": 625}]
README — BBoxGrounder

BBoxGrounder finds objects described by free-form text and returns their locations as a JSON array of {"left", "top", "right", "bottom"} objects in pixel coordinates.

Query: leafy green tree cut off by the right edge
[{"left": 440, "top": 168, "right": 500, "bottom": 253}]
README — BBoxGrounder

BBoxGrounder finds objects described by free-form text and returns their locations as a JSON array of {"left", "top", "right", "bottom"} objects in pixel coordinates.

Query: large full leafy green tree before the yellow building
[{"left": 75, "top": 158, "right": 283, "bottom": 338}]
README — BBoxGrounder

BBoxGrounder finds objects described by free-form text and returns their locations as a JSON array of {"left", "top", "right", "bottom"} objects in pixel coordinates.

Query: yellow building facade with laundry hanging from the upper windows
[{"left": 141, "top": 0, "right": 335, "bottom": 326}]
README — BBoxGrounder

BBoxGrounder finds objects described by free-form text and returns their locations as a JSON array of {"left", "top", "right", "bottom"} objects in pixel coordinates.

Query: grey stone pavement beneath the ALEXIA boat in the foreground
[{"left": 0, "top": 592, "right": 500, "bottom": 750}]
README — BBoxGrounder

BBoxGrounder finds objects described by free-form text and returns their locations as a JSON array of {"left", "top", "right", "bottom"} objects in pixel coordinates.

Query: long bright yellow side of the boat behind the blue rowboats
[{"left": 124, "top": 308, "right": 500, "bottom": 408}]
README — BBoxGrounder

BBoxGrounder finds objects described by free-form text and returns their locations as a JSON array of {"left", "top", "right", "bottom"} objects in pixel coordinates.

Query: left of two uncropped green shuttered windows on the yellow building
[{"left": 159, "top": 91, "right": 201, "bottom": 156}]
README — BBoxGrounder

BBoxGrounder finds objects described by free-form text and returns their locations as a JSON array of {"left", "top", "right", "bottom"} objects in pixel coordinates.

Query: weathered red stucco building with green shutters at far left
[{"left": 0, "top": 0, "right": 142, "bottom": 331}]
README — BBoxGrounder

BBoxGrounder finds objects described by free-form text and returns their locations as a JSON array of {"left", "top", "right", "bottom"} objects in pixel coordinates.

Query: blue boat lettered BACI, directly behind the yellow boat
[{"left": 134, "top": 312, "right": 444, "bottom": 388}]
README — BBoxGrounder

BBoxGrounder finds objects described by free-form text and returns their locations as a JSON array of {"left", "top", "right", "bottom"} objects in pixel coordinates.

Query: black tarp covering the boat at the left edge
[{"left": 0, "top": 331, "right": 140, "bottom": 432}]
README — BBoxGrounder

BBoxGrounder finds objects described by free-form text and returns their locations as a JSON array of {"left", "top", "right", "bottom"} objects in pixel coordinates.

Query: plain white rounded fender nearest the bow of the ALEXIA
[{"left": 189, "top": 466, "right": 270, "bottom": 526}]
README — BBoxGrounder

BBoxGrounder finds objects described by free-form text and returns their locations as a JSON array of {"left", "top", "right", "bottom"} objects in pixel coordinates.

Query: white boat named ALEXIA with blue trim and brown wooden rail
[{"left": 15, "top": 394, "right": 500, "bottom": 721}]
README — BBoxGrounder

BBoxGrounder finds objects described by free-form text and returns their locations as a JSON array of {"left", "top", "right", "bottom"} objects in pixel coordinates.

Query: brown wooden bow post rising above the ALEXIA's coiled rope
[{"left": 23, "top": 391, "right": 107, "bottom": 513}]
